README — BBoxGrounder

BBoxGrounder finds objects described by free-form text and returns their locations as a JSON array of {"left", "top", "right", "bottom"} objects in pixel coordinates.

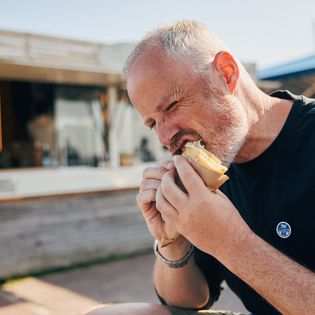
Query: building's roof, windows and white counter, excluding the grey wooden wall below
[{"left": 0, "top": 30, "right": 276, "bottom": 198}]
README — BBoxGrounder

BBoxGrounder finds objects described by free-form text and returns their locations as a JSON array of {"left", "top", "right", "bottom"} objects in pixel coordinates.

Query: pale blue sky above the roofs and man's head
[{"left": 0, "top": 0, "right": 315, "bottom": 68}]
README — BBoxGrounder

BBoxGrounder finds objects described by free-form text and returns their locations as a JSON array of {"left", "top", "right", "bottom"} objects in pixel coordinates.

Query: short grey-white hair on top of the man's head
[{"left": 123, "top": 20, "right": 226, "bottom": 79}]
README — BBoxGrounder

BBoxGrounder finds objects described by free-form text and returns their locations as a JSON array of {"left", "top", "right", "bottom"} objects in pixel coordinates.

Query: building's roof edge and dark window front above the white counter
[{"left": 0, "top": 31, "right": 160, "bottom": 173}]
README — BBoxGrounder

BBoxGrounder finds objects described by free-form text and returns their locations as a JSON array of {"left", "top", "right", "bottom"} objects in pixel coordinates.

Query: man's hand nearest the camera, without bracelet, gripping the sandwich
[{"left": 156, "top": 156, "right": 249, "bottom": 257}]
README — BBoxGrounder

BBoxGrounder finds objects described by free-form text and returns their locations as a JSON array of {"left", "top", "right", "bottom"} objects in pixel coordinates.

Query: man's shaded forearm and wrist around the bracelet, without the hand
[{"left": 153, "top": 239, "right": 209, "bottom": 308}]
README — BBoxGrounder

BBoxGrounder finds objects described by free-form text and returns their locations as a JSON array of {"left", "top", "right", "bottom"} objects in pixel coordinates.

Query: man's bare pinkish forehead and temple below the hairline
[{"left": 127, "top": 47, "right": 196, "bottom": 114}]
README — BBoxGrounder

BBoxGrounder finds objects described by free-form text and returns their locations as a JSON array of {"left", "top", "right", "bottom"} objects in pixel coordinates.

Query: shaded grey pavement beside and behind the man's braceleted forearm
[{"left": 41, "top": 254, "right": 246, "bottom": 313}]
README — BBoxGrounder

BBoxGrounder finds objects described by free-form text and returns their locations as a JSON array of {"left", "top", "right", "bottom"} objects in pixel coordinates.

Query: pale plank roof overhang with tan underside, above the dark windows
[{"left": 0, "top": 30, "right": 133, "bottom": 86}]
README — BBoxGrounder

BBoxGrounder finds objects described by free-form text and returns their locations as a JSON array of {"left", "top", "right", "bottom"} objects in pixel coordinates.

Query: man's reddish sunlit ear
[{"left": 213, "top": 51, "right": 240, "bottom": 93}]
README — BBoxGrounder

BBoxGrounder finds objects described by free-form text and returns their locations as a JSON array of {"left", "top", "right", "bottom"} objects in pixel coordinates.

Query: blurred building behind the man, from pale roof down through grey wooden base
[{"left": 0, "top": 31, "right": 282, "bottom": 280}]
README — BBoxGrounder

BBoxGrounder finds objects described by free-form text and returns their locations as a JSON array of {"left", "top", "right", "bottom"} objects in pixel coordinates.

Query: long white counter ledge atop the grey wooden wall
[{"left": 0, "top": 163, "right": 152, "bottom": 201}]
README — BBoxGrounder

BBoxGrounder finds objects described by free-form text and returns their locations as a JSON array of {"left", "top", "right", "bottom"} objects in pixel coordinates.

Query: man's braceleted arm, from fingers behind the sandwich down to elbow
[{"left": 137, "top": 162, "right": 220, "bottom": 308}]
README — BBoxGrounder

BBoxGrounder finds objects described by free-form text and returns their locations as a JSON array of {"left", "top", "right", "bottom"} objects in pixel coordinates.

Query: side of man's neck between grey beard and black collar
[{"left": 234, "top": 94, "right": 293, "bottom": 163}]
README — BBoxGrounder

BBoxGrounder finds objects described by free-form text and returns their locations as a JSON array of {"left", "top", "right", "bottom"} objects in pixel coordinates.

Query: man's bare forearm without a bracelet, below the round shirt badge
[{"left": 217, "top": 232, "right": 315, "bottom": 314}]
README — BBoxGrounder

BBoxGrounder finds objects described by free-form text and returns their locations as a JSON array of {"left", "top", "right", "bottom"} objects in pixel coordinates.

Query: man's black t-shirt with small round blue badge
[{"left": 195, "top": 91, "right": 315, "bottom": 315}]
